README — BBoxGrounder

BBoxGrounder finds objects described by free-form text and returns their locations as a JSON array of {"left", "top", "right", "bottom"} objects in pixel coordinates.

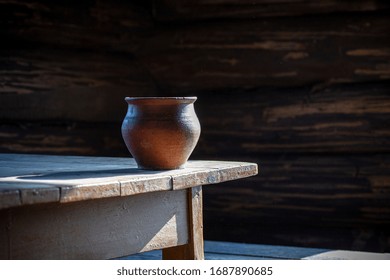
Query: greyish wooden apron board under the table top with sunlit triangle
[{"left": 0, "top": 190, "right": 189, "bottom": 259}]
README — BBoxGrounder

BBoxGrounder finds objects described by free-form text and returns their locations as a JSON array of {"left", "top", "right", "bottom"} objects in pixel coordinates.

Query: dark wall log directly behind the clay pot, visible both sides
[{"left": 0, "top": 83, "right": 390, "bottom": 154}]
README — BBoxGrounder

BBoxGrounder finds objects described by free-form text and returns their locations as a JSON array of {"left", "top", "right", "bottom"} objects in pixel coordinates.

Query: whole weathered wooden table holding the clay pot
[{"left": 0, "top": 154, "right": 257, "bottom": 259}]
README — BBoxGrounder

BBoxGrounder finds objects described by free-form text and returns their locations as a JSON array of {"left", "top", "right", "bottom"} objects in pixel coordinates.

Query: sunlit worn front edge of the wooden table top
[{"left": 0, "top": 155, "right": 258, "bottom": 210}]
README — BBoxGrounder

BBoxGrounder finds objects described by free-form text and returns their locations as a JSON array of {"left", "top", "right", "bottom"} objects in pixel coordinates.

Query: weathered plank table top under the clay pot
[{"left": 0, "top": 154, "right": 258, "bottom": 209}]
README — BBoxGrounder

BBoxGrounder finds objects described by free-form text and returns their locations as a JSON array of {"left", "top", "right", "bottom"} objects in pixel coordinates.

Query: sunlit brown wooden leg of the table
[{"left": 163, "top": 186, "right": 204, "bottom": 260}]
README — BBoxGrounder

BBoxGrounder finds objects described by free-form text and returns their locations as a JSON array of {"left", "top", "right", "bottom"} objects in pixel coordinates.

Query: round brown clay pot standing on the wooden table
[{"left": 122, "top": 97, "right": 200, "bottom": 169}]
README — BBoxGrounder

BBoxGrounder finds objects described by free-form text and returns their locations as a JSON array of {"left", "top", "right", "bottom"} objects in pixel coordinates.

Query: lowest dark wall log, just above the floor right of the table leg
[{"left": 204, "top": 220, "right": 390, "bottom": 253}]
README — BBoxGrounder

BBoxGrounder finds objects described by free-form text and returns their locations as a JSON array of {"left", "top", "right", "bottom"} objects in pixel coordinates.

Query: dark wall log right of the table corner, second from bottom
[{"left": 205, "top": 155, "right": 390, "bottom": 229}]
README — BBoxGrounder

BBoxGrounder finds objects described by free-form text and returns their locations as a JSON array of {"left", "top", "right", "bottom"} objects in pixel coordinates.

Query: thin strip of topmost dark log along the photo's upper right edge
[{"left": 153, "top": 0, "right": 389, "bottom": 21}]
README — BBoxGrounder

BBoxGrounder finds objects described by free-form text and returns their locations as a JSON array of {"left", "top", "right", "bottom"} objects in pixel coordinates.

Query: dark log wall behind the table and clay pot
[{"left": 0, "top": 0, "right": 390, "bottom": 252}]
